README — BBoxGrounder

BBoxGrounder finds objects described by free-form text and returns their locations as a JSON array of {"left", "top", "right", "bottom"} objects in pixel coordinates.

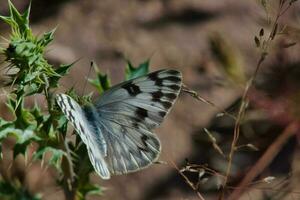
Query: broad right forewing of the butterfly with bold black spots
[{"left": 96, "top": 70, "right": 181, "bottom": 130}]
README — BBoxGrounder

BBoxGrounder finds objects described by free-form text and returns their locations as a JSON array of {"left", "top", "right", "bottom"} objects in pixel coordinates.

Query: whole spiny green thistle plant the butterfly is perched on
[{"left": 0, "top": 1, "right": 149, "bottom": 200}]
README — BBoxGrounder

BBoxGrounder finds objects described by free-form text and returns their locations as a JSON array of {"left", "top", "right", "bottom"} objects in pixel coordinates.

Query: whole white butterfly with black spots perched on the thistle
[{"left": 56, "top": 69, "right": 182, "bottom": 179}]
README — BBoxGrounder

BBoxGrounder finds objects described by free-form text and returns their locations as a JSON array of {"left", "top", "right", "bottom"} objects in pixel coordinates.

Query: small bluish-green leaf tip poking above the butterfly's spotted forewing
[{"left": 125, "top": 59, "right": 150, "bottom": 80}]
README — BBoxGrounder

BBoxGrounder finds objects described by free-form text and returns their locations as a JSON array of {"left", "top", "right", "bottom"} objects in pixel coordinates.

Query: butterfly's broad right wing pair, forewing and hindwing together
[{"left": 95, "top": 70, "right": 182, "bottom": 174}]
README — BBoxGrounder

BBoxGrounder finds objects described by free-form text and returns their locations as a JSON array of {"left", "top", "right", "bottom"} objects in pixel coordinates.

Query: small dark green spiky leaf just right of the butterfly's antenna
[{"left": 88, "top": 62, "right": 111, "bottom": 94}]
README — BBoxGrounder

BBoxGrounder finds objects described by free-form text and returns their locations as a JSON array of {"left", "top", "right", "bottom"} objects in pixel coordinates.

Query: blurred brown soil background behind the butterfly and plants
[{"left": 0, "top": 0, "right": 300, "bottom": 200}]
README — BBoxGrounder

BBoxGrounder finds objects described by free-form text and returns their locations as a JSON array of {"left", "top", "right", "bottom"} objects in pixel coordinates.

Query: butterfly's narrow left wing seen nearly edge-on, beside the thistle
[{"left": 56, "top": 94, "right": 110, "bottom": 179}]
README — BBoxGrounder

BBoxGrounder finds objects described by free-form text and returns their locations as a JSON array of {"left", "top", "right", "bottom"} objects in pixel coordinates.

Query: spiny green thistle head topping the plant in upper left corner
[{"left": 0, "top": 1, "right": 64, "bottom": 99}]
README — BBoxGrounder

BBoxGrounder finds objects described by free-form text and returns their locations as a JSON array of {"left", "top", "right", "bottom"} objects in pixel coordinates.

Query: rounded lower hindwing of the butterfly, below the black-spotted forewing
[{"left": 96, "top": 116, "right": 160, "bottom": 174}]
